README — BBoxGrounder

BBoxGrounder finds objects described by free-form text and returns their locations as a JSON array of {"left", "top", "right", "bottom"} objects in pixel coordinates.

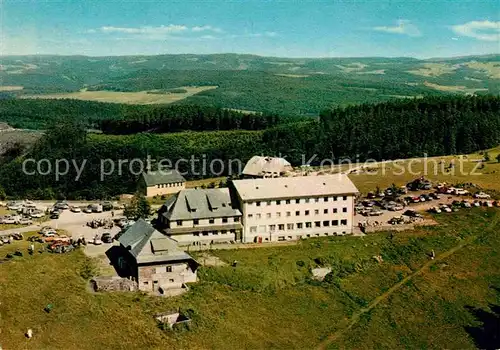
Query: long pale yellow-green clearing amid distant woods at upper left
[{"left": 20, "top": 86, "right": 217, "bottom": 105}]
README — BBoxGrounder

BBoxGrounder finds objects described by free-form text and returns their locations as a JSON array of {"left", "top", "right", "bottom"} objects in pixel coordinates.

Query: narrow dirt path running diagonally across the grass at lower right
[{"left": 317, "top": 214, "right": 499, "bottom": 349}]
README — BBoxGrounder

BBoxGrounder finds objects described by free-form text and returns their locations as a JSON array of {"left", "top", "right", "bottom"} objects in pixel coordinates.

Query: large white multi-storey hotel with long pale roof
[{"left": 233, "top": 174, "right": 358, "bottom": 243}]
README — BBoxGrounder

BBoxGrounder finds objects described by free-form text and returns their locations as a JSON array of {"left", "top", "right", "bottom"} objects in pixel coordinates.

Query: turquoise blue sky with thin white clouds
[{"left": 0, "top": 0, "right": 500, "bottom": 58}]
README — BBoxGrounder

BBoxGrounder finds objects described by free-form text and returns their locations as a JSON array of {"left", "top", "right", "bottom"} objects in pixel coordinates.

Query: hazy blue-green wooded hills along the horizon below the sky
[{"left": 0, "top": 54, "right": 500, "bottom": 115}]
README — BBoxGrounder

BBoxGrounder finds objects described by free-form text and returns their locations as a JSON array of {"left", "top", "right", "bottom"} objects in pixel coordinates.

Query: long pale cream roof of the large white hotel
[{"left": 233, "top": 174, "right": 359, "bottom": 201}]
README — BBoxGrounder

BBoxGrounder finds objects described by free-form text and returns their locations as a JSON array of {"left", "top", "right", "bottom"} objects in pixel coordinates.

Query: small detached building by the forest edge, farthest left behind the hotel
[{"left": 138, "top": 169, "right": 186, "bottom": 197}]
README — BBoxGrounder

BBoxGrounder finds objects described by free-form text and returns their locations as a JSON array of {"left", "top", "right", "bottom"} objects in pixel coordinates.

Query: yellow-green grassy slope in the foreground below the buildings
[{"left": 0, "top": 209, "right": 500, "bottom": 349}]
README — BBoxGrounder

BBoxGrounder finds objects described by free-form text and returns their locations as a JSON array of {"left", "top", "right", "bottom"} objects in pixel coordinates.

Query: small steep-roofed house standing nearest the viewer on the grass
[{"left": 117, "top": 219, "right": 199, "bottom": 294}]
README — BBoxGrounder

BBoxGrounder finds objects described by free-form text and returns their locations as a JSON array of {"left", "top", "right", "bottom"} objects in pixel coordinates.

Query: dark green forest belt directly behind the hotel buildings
[{"left": 0, "top": 96, "right": 500, "bottom": 199}]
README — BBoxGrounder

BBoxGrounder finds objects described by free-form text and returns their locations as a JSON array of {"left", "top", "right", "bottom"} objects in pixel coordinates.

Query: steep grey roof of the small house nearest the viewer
[{"left": 118, "top": 219, "right": 196, "bottom": 264}]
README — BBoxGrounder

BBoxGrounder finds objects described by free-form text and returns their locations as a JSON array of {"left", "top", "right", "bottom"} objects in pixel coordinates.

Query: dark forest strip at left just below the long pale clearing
[{"left": 0, "top": 99, "right": 308, "bottom": 131}]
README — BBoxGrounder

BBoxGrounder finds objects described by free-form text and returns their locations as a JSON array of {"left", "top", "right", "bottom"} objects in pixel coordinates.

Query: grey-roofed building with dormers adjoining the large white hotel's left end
[{"left": 157, "top": 188, "right": 242, "bottom": 245}]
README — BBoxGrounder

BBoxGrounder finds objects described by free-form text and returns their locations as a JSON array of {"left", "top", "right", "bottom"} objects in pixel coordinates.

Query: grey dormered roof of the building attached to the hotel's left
[{"left": 160, "top": 188, "right": 241, "bottom": 220}]
